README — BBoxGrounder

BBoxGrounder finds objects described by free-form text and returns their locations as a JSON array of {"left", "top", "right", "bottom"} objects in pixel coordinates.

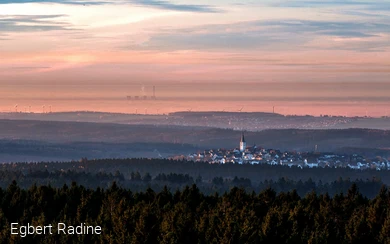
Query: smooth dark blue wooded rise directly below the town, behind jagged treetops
[{"left": 0, "top": 158, "right": 390, "bottom": 185}]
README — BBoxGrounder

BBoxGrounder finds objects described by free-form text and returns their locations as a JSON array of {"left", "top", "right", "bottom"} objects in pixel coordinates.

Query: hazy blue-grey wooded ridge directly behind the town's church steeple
[{"left": 0, "top": 120, "right": 390, "bottom": 153}]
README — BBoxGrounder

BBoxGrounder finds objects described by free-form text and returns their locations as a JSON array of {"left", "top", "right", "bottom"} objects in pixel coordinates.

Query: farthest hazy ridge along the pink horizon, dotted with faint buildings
[{"left": 0, "top": 109, "right": 390, "bottom": 131}]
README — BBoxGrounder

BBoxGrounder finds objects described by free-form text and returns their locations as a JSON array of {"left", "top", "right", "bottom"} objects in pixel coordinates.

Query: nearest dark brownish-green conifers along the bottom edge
[{"left": 0, "top": 182, "right": 390, "bottom": 244}]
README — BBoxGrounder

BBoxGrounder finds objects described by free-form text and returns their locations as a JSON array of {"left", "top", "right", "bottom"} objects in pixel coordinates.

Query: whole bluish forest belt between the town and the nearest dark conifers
[{"left": 0, "top": 158, "right": 390, "bottom": 198}]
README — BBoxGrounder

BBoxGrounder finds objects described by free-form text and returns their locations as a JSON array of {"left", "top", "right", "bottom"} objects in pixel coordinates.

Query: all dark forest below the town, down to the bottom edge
[{"left": 0, "top": 159, "right": 390, "bottom": 243}]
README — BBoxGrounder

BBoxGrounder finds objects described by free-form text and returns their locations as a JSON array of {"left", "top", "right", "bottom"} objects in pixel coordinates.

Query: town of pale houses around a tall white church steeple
[{"left": 181, "top": 133, "right": 390, "bottom": 170}]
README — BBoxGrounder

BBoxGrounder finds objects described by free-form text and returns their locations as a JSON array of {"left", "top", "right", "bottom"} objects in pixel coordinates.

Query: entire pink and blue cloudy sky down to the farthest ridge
[{"left": 0, "top": 0, "right": 390, "bottom": 116}]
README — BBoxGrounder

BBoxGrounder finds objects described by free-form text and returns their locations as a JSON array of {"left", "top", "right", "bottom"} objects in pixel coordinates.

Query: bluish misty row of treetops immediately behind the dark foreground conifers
[{"left": 0, "top": 170, "right": 383, "bottom": 198}]
